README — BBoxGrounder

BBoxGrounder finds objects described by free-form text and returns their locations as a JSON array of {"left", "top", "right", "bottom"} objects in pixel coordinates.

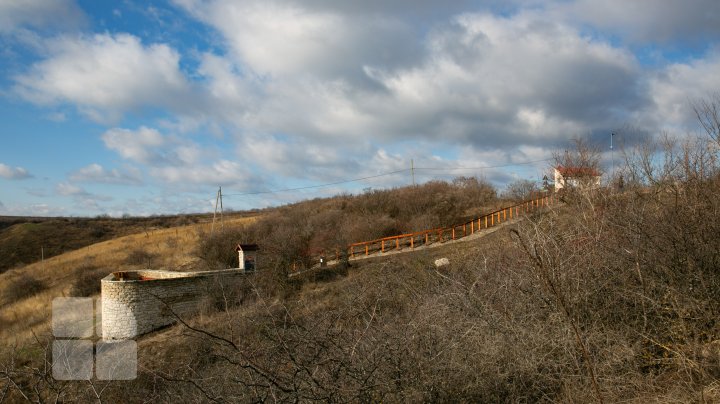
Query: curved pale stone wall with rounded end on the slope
[{"left": 101, "top": 269, "right": 244, "bottom": 340}]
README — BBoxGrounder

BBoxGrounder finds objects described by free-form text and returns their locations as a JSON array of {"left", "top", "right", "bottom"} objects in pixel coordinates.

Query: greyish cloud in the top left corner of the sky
[{"left": 0, "top": 0, "right": 85, "bottom": 34}]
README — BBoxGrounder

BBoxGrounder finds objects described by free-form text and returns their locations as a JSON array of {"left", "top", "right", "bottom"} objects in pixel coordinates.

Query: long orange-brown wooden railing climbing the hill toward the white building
[{"left": 348, "top": 194, "right": 554, "bottom": 258}]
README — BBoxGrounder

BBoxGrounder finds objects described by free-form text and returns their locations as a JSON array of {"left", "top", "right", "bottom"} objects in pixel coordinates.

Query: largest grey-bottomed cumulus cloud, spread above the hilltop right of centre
[{"left": 225, "top": 14, "right": 647, "bottom": 152}]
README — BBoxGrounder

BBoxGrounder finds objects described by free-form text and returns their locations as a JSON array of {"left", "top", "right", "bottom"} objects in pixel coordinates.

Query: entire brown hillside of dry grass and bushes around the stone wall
[{"left": 0, "top": 149, "right": 720, "bottom": 403}]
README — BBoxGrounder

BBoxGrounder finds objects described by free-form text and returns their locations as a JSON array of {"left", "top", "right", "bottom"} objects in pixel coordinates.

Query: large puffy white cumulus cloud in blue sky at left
[{"left": 15, "top": 34, "right": 190, "bottom": 121}]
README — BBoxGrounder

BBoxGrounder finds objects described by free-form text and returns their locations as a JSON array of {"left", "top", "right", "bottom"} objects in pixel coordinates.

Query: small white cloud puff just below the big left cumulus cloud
[{"left": 102, "top": 126, "right": 166, "bottom": 163}]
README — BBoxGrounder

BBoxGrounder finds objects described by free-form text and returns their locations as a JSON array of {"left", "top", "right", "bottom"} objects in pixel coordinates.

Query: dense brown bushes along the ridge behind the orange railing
[{"left": 198, "top": 177, "right": 498, "bottom": 272}]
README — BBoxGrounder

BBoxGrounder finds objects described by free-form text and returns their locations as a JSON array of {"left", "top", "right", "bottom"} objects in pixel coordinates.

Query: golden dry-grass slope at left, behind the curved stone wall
[{"left": 0, "top": 217, "right": 255, "bottom": 345}]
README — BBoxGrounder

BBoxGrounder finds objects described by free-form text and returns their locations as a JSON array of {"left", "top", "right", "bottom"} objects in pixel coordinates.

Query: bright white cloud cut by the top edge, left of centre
[{"left": 176, "top": 0, "right": 420, "bottom": 81}]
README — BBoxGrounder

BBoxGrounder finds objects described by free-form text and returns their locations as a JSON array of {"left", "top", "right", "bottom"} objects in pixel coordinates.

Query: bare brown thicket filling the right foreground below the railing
[{"left": 145, "top": 132, "right": 720, "bottom": 402}]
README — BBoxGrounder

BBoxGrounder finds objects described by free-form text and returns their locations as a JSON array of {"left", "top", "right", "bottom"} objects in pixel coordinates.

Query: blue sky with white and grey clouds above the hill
[{"left": 0, "top": 0, "right": 720, "bottom": 216}]
